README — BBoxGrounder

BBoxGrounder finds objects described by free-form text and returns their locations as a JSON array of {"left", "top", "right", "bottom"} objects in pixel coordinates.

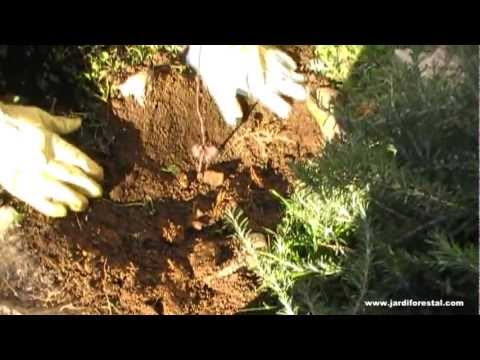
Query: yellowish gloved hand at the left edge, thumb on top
[{"left": 0, "top": 102, "right": 103, "bottom": 217}]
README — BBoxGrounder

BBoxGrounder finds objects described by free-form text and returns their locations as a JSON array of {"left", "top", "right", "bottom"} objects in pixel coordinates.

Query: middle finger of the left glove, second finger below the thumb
[{"left": 46, "top": 161, "right": 102, "bottom": 197}]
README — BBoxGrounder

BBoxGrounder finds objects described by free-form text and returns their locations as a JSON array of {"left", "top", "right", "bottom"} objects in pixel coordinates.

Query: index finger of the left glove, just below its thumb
[{"left": 52, "top": 136, "right": 103, "bottom": 181}]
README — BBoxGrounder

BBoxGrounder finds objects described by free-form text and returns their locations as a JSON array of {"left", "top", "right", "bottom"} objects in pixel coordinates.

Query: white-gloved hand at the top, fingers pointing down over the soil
[{"left": 187, "top": 45, "right": 307, "bottom": 125}]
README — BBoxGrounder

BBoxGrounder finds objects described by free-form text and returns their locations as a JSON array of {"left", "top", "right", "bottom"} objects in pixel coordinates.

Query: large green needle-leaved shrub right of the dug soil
[{"left": 227, "top": 46, "right": 478, "bottom": 314}]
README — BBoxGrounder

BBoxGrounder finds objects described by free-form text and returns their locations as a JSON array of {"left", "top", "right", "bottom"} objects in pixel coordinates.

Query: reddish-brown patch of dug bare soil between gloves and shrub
[{"left": 0, "top": 57, "right": 328, "bottom": 314}]
